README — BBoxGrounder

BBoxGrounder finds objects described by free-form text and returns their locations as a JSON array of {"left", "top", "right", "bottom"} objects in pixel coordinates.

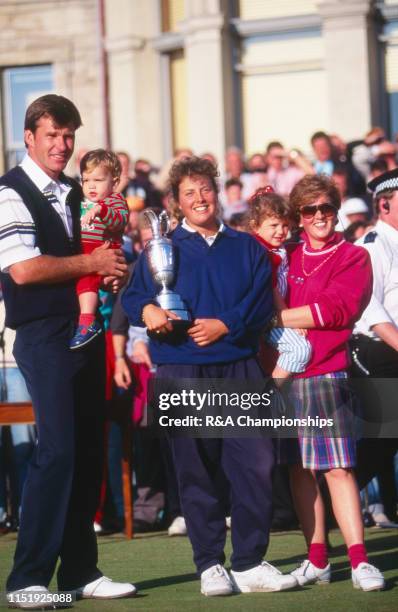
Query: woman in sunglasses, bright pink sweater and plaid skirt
[{"left": 278, "top": 175, "right": 384, "bottom": 591}]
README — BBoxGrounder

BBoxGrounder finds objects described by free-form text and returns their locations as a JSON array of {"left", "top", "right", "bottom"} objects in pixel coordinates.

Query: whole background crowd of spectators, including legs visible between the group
[{"left": 0, "top": 127, "right": 398, "bottom": 535}]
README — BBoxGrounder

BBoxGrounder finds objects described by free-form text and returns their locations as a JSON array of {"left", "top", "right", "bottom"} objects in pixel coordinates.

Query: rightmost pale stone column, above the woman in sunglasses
[{"left": 318, "top": 0, "right": 379, "bottom": 140}]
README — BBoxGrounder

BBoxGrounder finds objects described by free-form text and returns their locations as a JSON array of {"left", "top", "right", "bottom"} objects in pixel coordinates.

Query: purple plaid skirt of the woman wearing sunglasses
[{"left": 279, "top": 372, "right": 358, "bottom": 470}]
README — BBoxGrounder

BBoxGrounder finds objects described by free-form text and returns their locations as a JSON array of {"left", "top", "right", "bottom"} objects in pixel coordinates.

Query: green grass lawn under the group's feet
[{"left": 0, "top": 529, "right": 398, "bottom": 612}]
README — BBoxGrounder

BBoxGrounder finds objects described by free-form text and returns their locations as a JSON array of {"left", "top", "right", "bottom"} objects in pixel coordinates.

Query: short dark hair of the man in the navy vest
[{"left": 24, "top": 94, "right": 82, "bottom": 132}]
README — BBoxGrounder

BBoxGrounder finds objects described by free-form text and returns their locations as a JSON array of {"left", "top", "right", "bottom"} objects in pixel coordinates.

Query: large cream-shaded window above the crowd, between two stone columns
[{"left": 238, "top": 31, "right": 329, "bottom": 154}]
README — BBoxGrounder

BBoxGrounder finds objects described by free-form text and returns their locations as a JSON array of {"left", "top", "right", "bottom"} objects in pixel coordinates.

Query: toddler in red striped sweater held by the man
[{"left": 70, "top": 149, "right": 129, "bottom": 350}]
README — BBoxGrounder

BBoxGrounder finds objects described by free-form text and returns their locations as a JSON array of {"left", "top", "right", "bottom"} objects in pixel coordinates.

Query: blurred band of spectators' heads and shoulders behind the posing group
[{"left": 109, "top": 127, "right": 398, "bottom": 250}]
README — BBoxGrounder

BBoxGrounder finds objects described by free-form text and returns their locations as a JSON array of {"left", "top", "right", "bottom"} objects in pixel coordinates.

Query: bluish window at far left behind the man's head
[{"left": 2, "top": 65, "right": 53, "bottom": 170}]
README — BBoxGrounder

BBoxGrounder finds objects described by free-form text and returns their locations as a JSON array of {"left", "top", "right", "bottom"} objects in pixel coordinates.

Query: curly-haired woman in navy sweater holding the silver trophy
[{"left": 123, "top": 157, "right": 297, "bottom": 596}]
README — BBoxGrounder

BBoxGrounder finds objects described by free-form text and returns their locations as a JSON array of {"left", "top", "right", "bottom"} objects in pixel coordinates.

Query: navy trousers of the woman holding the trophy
[{"left": 157, "top": 359, "right": 274, "bottom": 573}]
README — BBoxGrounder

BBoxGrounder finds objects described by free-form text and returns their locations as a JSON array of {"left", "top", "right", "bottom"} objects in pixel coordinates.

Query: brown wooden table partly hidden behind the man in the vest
[{"left": 0, "top": 402, "right": 133, "bottom": 540}]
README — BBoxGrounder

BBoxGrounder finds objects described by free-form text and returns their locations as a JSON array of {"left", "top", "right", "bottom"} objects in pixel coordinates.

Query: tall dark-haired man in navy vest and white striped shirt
[{"left": 0, "top": 94, "right": 135, "bottom": 608}]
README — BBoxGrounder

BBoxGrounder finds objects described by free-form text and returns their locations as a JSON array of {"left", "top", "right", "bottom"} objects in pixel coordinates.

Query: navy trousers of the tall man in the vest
[{"left": 7, "top": 317, "right": 105, "bottom": 591}]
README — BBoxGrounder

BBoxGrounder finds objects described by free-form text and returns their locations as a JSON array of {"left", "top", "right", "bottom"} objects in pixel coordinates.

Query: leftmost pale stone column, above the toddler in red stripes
[{"left": 105, "top": 0, "right": 162, "bottom": 163}]
